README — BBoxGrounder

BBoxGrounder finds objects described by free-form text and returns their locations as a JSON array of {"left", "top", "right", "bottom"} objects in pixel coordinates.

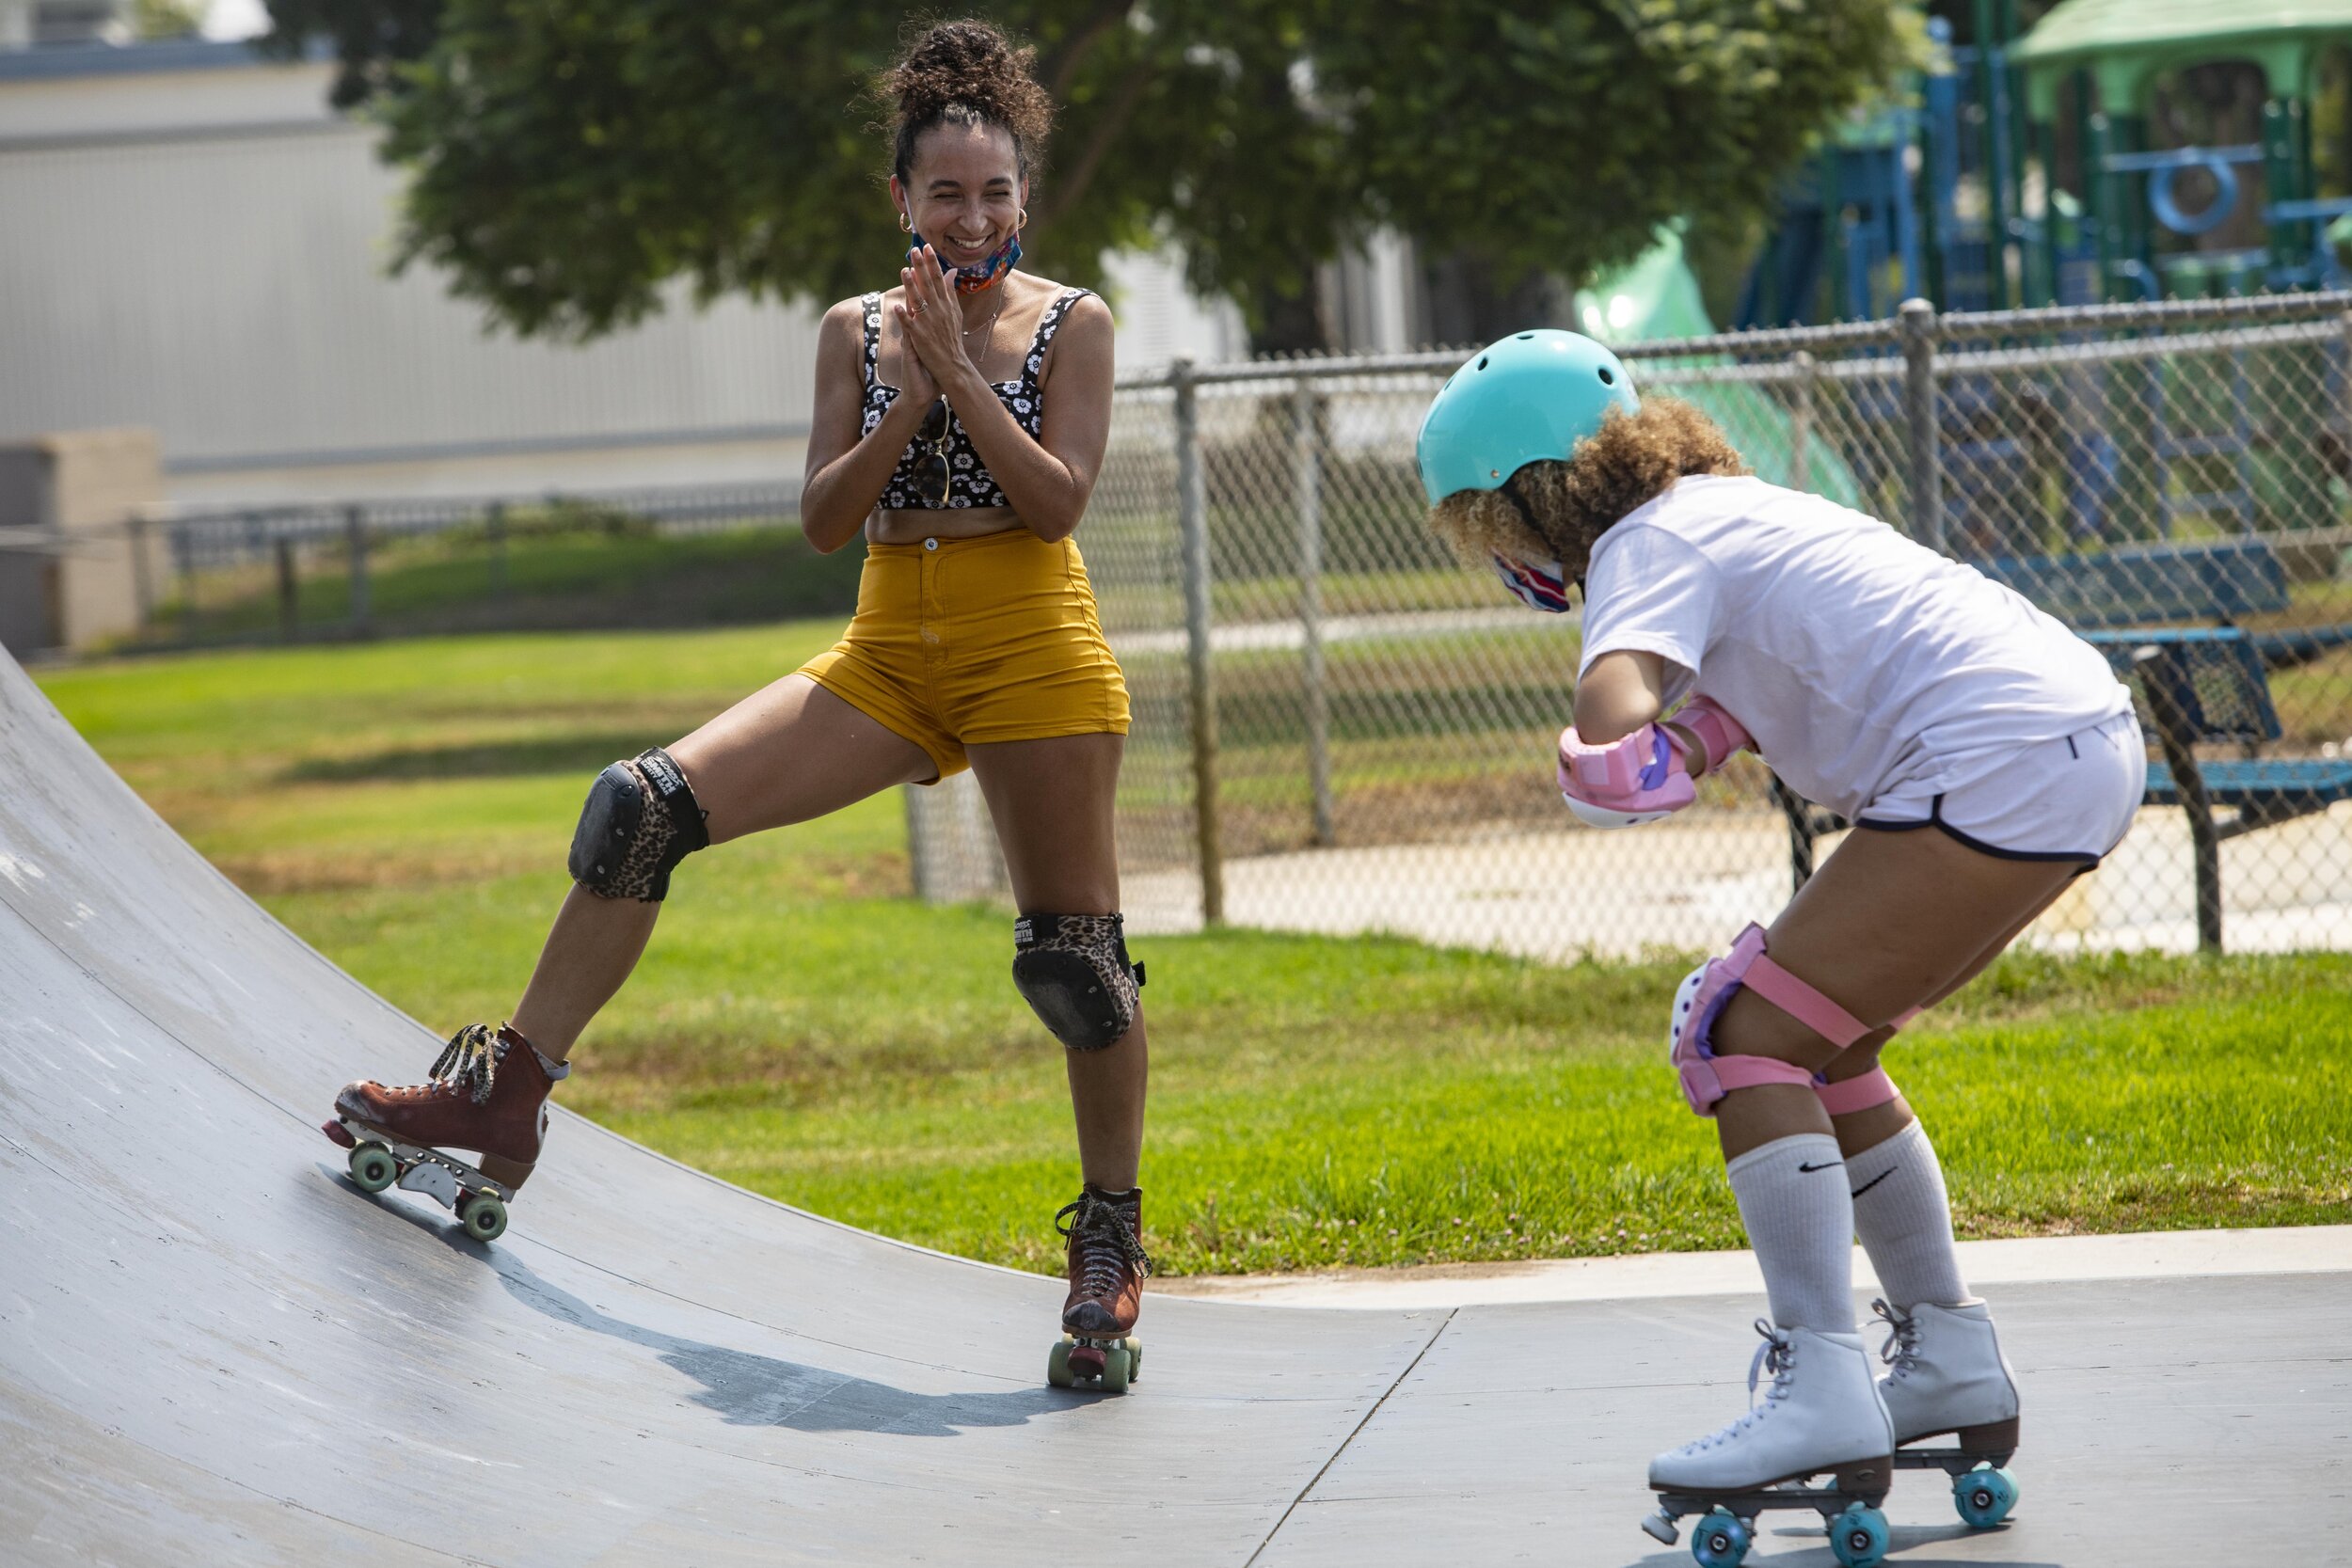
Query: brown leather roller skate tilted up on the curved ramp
[{"left": 320, "top": 1022, "right": 572, "bottom": 1242}]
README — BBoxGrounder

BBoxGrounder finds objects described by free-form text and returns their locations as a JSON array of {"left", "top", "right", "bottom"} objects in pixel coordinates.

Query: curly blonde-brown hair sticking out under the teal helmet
[{"left": 1430, "top": 397, "right": 1748, "bottom": 578}]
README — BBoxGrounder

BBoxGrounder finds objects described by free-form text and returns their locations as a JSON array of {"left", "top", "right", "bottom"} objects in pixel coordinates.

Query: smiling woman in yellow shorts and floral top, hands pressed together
[{"left": 329, "top": 21, "right": 1151, "bottom": 1387}]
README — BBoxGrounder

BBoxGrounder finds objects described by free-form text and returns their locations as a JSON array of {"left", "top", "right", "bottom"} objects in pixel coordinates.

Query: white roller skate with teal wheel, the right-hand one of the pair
[{"left": 1870, "top": 1300, "right": 2018, "bottom": 1530}]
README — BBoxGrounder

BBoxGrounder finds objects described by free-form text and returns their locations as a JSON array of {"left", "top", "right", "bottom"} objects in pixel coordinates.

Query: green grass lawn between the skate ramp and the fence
[{"left": 42, "top": 621, "right": 2352, "bottom": 1272}]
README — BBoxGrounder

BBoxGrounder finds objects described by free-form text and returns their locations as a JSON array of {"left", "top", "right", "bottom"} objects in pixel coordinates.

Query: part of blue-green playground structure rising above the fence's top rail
[{"left": 1736, "top": 0, "right": 2352, "bottom": 326}]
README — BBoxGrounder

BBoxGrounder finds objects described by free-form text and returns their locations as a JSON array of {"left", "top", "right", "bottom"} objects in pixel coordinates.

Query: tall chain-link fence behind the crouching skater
[{"left": 915, "top": 293, "right": 2352, "bottom": 957}]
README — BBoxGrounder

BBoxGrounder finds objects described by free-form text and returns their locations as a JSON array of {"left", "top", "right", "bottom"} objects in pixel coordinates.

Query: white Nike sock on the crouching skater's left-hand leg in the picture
[{"left": 1726, "top": 1133, "right": 1853, "bottom": 1333}]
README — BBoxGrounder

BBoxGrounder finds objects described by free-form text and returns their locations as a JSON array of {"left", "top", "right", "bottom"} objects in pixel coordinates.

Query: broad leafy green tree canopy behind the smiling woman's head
[{"left": 271, "top": 0, "right": 1910, "bottom": 348}]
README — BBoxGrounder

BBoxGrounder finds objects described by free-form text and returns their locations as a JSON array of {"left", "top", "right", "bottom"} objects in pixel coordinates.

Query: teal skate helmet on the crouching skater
[{"left": 1414, "top": 326, "right": 1642, "bottom": 505}]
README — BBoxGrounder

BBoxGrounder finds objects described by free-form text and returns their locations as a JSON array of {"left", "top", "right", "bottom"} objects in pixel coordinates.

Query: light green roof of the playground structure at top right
[{"left": 2009, "top": 0, "right": 2352, "bottom": 118}]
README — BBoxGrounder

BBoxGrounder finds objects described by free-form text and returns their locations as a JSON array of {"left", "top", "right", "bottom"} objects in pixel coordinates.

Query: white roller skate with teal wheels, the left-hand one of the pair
[{"left": 1642, "top": 1319, "right": 1896, "bottom": 1568}]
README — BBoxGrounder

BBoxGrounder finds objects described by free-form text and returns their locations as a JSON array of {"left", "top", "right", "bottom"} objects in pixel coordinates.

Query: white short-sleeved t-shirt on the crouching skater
[{"left": 1579, "top": 475, "right": 2131, "bottom": 818}]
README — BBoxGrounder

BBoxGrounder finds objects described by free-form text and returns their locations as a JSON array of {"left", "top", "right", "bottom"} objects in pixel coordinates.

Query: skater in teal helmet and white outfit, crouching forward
[{"left": 1419, "top": 331, "right": 2148, "bottom": 1566}]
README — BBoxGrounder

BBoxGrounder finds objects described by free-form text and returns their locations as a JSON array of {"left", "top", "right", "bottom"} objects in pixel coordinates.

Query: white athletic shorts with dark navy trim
[{"left": 1853, "top": 712, "right": 2148, "bottom": 870}]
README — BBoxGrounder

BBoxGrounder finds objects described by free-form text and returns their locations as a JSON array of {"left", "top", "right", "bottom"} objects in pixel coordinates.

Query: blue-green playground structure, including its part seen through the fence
[{"left": 1675, "top": 0, "right": 2352, "bottom": 560}]
